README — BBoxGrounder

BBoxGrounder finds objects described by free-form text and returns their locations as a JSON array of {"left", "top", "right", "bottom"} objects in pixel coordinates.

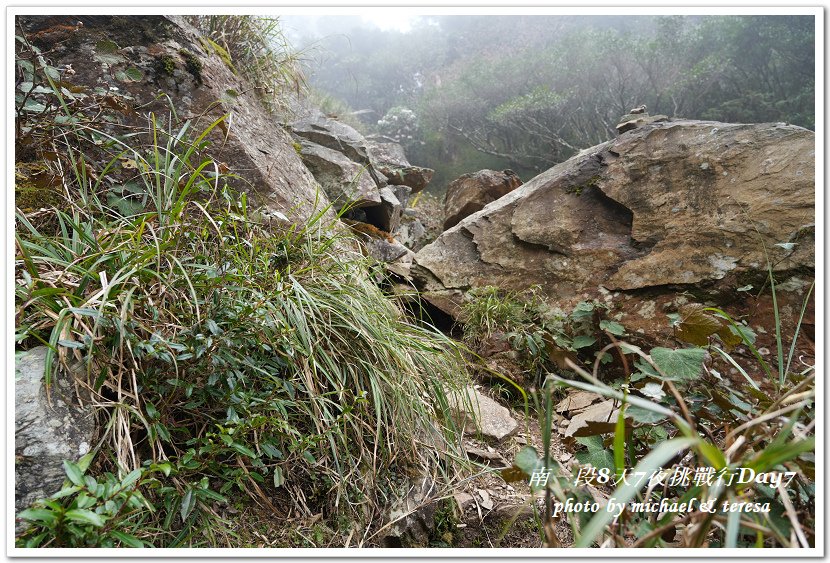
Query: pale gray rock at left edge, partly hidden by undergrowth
[{"left": 14, "top": 346, "right": 95, "bottom": 511}]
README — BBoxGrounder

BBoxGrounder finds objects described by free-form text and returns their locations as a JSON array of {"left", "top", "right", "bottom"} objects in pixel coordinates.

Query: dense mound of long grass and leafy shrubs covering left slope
[{"left": 15, "top": 98, "right": 472, "bottom": 547}]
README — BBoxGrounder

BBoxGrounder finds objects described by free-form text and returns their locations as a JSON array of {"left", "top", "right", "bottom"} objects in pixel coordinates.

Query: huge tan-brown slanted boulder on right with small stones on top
[{"left": 413, "top": 120, "right": 815, "bottom": 322}]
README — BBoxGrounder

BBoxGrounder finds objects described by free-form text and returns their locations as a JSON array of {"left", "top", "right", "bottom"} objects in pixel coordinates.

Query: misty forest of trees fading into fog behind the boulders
[{"left": 284, "top": 16, "right": 815, "bottom": 188}]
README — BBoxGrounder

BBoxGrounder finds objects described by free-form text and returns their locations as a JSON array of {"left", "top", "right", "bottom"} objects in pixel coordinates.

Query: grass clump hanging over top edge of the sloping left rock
[{"left": 188, "top": 15, "right": 306, "bottom": 112}]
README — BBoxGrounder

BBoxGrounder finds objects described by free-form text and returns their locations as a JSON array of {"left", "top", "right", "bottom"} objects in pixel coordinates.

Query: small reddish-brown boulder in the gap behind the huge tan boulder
[{"left": 444, "top": 170, "right": 522, "bottom": 230}]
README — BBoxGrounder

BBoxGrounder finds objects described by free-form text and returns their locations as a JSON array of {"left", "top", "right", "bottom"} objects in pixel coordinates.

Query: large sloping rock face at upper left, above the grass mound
[{"left": 17, "top": 15, "right": 333, "bottom": 220}]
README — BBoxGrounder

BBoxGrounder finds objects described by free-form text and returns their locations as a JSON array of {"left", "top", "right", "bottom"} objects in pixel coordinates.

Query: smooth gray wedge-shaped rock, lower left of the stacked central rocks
[{"left": 300, "top": 141, "right": 382, "bottom": 210}]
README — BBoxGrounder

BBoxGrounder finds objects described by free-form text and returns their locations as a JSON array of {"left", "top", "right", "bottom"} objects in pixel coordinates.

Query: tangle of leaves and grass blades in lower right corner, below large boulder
[{"left": 474, "top": 280, "right": 817, "bottom": 548}]
